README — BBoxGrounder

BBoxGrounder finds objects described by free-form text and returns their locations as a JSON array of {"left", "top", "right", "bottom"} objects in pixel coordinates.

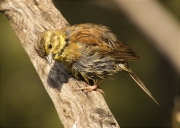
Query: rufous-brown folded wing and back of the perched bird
[{"left": 66, "top": 24, "right": 140, "bottom": 61}]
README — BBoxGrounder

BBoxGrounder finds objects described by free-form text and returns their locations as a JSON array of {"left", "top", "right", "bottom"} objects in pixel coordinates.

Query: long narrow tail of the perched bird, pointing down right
[{"left": 119, "top": 63, "right": 159, "bottom": 105}]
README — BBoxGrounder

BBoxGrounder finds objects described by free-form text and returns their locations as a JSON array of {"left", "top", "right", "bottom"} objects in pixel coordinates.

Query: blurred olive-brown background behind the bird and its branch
[{"left": 0, "top": 0, "right": 180, "bottom": 128}]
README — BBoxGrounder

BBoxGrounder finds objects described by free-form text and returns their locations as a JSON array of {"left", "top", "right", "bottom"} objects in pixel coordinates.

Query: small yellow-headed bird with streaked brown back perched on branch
[{"left": 37, "top": 23, "right": 158, "bottom": 104}]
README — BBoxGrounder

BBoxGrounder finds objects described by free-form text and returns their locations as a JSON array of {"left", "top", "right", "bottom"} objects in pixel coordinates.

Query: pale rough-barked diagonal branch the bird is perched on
[{"left": 0, "top": 0, "right": 119, "bottom": 128}]
